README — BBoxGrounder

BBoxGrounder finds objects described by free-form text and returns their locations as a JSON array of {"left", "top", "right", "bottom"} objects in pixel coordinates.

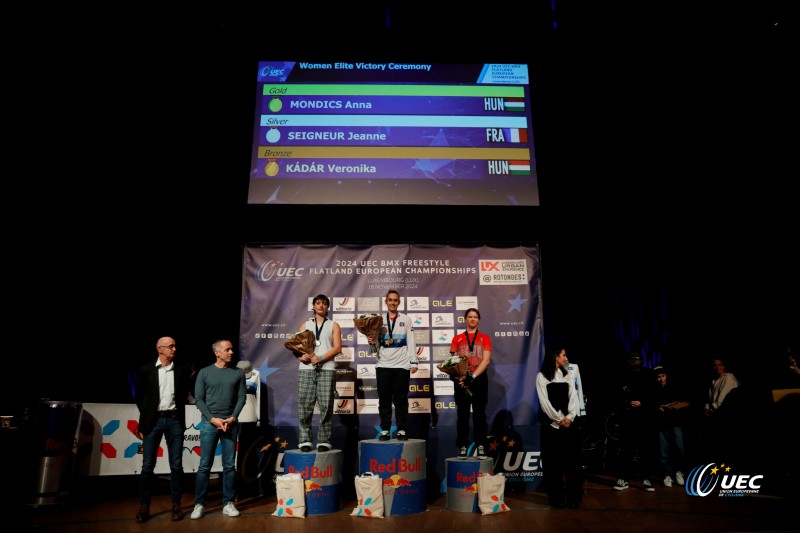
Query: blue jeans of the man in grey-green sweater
[{"left": 194, "top": 418, "right": 239, "bottom": 505}]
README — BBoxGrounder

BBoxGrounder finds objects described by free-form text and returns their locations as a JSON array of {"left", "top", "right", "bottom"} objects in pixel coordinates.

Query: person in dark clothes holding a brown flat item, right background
[{"left": 653, "top": 366, "right": 689, "bottom": 487}]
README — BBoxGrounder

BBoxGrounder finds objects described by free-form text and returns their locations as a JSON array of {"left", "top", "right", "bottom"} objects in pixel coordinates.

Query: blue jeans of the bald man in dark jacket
[{"left": 139, "top": 417, "right": 183, "bottom": 505}]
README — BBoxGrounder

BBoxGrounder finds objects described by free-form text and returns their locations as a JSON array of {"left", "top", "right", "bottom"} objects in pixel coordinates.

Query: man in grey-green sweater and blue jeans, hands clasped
[{"left": 190, "top": 339, "right": 247, "bottom": 520}]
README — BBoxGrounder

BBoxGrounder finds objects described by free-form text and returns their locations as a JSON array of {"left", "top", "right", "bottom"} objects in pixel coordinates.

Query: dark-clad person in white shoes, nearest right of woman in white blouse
[{"left": 614, "top": 352, "right": 656, "bottom": 492}]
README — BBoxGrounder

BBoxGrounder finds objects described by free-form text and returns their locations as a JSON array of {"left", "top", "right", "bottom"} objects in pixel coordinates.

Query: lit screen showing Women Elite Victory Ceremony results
[{"left": 248, "top": 61, "right": 539, "bottom": 206}]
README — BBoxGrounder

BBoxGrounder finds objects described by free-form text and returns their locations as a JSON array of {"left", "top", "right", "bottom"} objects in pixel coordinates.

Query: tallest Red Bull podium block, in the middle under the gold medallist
[{"left": 358, "top": 439, "right": 427, "bottom": 516}]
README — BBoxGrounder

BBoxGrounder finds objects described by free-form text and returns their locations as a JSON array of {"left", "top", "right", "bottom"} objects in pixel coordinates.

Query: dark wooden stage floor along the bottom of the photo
[{"left": 15, "top": 476, "right": 800, "bottom": 533}]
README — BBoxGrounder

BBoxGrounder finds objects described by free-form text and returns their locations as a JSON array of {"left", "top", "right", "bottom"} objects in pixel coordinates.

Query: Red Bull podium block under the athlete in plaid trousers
[{"left": 283, "top": 449, "right": 343, "bottom": 515}]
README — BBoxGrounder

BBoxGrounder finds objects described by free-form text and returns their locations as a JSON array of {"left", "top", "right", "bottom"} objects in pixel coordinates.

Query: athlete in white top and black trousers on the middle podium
[{"left": 368, "top": 289, "right": 419, "bottom": 441}]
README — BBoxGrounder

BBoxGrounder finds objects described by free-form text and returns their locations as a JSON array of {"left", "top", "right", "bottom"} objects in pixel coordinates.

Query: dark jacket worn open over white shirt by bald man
[{"left": 136, "top": 361, "right": 191, "bottom": 435}]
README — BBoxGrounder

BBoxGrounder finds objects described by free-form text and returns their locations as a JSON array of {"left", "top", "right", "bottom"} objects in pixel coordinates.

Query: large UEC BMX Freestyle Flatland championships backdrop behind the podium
[{"left": 240, "top": 244, "right": 543, "bottom": 491}]
